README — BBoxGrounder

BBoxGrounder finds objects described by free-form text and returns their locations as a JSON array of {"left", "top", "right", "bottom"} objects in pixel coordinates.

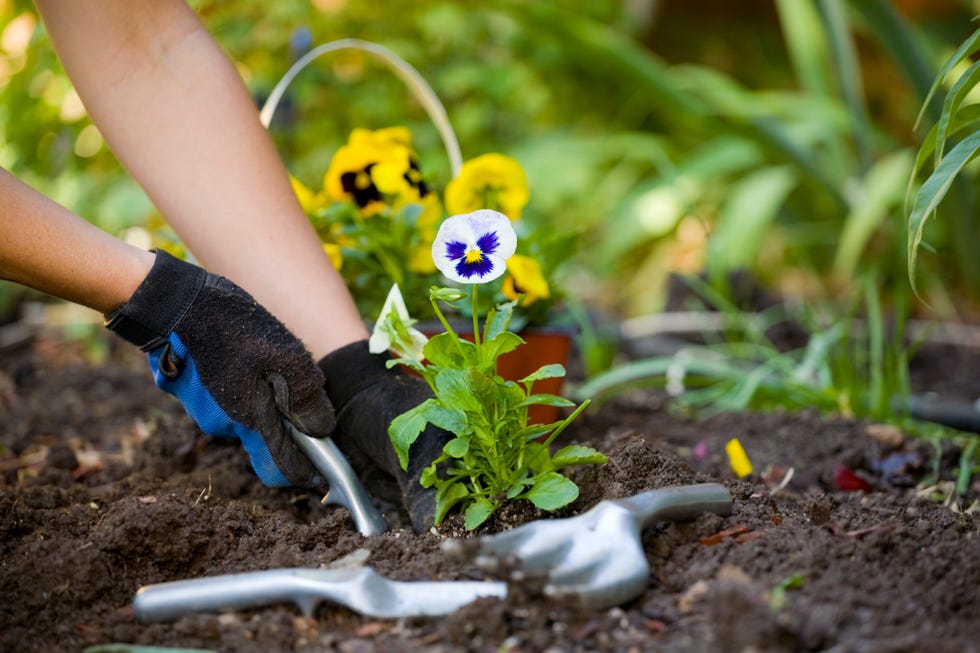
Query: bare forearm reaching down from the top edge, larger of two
[{"left": 38, "top": 0, "right": 366, "bottom": 355}]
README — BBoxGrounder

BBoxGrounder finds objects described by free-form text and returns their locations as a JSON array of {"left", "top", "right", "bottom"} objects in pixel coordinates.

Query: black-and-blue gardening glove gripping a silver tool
[{"left": 106, "top": 251, "right": 334, "bottom": 488}]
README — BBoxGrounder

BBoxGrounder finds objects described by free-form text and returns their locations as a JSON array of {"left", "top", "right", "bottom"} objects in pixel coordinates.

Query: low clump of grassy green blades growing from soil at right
[{"left": 575, "top": 277, "right": 914, "bottom": 425}]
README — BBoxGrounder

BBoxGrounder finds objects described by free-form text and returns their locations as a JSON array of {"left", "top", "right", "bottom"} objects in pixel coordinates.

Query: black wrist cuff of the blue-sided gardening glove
[{"left": 105, "top": 250, "right": 208, "bottom": 351}]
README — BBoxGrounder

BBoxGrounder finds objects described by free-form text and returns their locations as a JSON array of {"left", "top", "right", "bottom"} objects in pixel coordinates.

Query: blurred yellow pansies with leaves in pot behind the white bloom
[{"left": 292, "top": 127, "right": 575, "bottom": 330}]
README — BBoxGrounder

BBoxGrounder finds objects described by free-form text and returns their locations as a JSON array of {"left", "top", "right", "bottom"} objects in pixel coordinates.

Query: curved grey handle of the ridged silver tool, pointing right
[{"left": 616, "top": 483, "right": 732, "bottom": 528}]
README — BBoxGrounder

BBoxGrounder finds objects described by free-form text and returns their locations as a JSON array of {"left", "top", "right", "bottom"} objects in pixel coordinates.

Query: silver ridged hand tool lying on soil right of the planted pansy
[{"left": 443, "top": 483, "right": 732, "bottom": 609}]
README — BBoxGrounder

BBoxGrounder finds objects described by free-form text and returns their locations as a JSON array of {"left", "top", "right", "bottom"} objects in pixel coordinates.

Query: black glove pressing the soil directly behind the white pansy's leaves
[{"left": 320, "top": 340, "right": 453, "bottom": 533}]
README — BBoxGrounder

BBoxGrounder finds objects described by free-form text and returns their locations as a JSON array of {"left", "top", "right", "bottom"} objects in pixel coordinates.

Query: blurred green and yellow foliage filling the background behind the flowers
[{"left": 0, "top": 0, "right": 980, "bottom": 318}]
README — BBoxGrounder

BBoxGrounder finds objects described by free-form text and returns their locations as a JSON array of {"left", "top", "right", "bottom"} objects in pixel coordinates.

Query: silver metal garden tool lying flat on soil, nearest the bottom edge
[{"left": 133, "top": 566, "right": 507, "bottom": 623}]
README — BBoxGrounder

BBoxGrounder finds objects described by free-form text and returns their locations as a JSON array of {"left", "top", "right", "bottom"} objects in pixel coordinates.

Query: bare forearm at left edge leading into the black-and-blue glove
[{"left": 0, "top": 170, "right": 153, "bottom": 313}]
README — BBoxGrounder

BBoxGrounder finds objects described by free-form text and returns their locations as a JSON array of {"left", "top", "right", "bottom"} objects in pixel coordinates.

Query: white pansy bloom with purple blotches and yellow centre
[{"left": 432, "top": 209, "right": 517, "bottom": 283}]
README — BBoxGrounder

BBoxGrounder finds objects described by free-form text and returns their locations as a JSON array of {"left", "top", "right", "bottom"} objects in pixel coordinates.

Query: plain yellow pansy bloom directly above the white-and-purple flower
[{"left": 446, "top": 152, "right": 529, "bottom": 220}]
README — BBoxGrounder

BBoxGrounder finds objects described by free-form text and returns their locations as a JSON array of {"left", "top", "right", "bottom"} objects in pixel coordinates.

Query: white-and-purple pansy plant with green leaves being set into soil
[{"left": 372, "top": 209, "right": 606, "bottom": 529}]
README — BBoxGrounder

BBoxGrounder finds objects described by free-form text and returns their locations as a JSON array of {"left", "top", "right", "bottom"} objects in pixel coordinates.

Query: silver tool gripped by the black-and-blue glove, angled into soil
[{"left": 283, "top": 420, "right": 388, "bottom": 537}]
